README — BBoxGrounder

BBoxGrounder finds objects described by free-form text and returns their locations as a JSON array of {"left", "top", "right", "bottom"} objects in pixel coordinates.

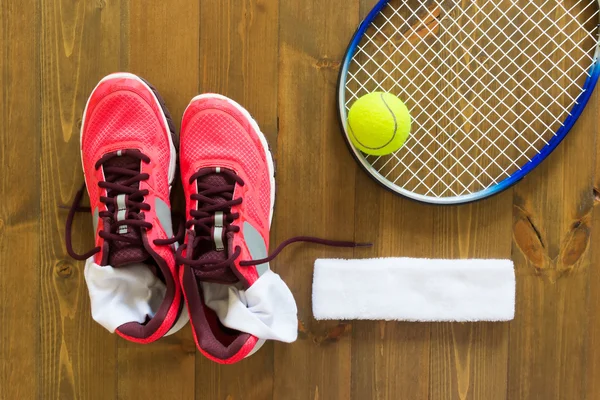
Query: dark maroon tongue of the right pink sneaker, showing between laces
[{"left": 192, "top": 173, "right": 237, "bottom": 282}]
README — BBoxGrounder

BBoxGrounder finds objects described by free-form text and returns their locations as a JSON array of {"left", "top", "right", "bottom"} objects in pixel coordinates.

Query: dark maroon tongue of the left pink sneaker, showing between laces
[{"left": 104, "top": 155, "right": 150, "bottom": 268}]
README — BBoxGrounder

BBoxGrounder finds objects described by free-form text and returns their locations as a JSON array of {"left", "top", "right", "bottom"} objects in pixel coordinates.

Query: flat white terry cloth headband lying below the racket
[{"left": 312, "top": 258, "right": 515, "bottom": 321}]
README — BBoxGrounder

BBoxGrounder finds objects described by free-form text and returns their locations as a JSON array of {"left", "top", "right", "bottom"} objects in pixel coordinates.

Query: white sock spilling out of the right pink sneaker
[{"left": 202, "top": 270, "right": 298, "bottom": 343}]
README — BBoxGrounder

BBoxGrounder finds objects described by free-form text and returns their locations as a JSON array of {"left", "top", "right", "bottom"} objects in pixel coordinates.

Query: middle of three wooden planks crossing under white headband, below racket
[{"left": 352, "top": 178, "right": 434, "bottom": 399}]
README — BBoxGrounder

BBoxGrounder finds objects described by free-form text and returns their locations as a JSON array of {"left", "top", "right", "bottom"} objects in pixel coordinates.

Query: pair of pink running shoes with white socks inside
[{"left": 66, "top": 73, "right": 354, "bottom": 364}]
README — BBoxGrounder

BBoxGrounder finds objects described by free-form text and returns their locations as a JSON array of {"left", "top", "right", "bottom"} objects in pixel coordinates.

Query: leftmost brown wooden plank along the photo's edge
[{"left": 0, "top": 1, "right": 40, "bottom": 399}]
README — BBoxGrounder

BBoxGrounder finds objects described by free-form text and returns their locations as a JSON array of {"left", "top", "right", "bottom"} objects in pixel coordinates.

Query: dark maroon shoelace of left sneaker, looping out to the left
[{"left": 65, "top": 150, "right": 177, "bottom": 260}]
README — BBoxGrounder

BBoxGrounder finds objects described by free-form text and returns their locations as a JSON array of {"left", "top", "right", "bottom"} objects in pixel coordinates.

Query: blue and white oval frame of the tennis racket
[{"left": 337, "top": 0, "right": 600, "bottom": 204}]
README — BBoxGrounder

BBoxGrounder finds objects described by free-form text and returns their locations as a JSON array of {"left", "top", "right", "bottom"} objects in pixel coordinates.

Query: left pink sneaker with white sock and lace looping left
[{"left": 66, "top": 73, "right": 188, "bottom": 343}]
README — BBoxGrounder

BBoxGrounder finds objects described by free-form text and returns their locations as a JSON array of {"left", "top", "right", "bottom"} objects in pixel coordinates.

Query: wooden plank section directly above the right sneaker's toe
[{"left": 200, "top": 0, "right": 279, "bottom": 143}]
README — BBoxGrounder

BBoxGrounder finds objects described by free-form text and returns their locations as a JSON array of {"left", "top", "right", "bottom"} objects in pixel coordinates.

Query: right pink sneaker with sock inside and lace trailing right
[{"left": 177, "top": 94, "right": 366, "bottom": 364}]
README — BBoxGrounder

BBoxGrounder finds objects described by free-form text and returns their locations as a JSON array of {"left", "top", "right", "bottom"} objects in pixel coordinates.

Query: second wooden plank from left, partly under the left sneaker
[{"left": 38, "top": 1, "right": 121, "bottom": 399}]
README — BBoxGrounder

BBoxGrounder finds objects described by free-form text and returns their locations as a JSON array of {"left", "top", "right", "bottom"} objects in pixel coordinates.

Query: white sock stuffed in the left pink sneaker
[{"left": 84, "top": 256, "right": 166, "bottom": 332}]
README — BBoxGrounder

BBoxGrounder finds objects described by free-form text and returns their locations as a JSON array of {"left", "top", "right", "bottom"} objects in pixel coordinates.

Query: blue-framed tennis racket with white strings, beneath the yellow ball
[{"left": 338, "top": 0, "right": 600, "bottom": 204}]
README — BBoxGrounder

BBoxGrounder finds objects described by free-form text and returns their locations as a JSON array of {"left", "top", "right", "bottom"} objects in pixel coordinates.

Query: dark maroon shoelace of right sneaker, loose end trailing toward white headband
[{"left": 176, "top": 168, "right": 372, "bottom": 276}]
